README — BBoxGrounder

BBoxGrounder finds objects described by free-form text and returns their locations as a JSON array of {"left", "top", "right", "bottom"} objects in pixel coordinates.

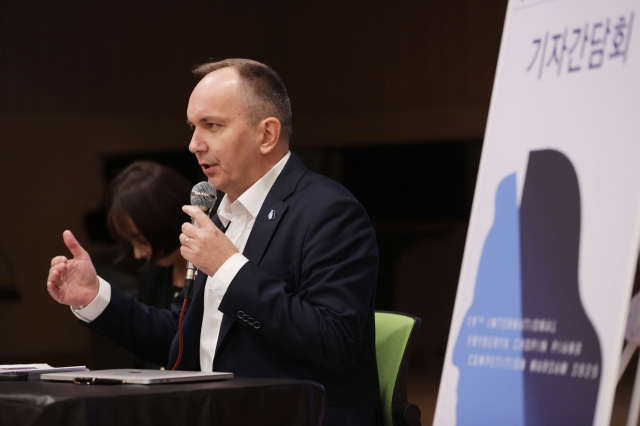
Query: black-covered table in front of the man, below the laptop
[{"left": 0, "top": 379, "right": 324, "bottom": 426}]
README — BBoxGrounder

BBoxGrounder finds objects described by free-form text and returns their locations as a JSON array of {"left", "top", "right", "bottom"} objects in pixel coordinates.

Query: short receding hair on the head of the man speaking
[{"left": 193, "top": 59, "right": 293, "bottom": 139}]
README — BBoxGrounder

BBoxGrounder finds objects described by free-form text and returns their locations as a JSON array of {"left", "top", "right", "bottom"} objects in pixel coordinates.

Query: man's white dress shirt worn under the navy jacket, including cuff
[{"left": 71, "top": 152, "right": 291, "bottom": 371}]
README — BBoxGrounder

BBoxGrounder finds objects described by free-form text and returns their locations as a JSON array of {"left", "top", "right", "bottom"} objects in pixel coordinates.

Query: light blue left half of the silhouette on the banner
[{"left": 453, "top": 174, "right": 524, "bottom": 426}]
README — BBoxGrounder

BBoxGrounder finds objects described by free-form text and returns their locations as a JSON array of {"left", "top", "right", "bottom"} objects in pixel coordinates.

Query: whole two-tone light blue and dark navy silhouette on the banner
[{"left": 453, "top": 150, "right": 602, "bottom": 426}]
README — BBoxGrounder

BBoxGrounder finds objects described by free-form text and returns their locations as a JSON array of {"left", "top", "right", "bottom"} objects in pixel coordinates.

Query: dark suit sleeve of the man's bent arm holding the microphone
[{"left": 219, "top": 196, "right": 378, "bottom": 372}]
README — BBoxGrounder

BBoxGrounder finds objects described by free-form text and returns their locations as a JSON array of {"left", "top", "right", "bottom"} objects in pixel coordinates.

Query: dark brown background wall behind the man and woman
[{"left": 0, "top": 0, "right": 507, "bottom": 366}]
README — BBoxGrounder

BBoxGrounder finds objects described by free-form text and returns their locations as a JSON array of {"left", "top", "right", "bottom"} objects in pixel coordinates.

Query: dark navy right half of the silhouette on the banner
[{"left": 520, "top": 150, "right": 602, "bottom": 426}]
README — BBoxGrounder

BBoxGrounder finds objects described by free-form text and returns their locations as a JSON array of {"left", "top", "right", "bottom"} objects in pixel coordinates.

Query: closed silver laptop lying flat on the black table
[{"left": 40, "top": 368, "right": 233, "bottom": 385}]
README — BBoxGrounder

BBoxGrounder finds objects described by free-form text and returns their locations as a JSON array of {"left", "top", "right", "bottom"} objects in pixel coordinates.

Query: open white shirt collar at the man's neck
[{"left": 218, "top": 151, "right": 291, "bottom": 228}]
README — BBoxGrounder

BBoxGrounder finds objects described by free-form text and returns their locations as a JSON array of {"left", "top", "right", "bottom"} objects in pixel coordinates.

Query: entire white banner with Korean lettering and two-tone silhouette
[{"left": 434, "top": 0, "right": 640, "bottom": 426}]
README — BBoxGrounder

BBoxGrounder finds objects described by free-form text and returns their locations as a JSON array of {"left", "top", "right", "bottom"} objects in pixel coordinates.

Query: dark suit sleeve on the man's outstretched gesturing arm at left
[{"left": 80, "top": 287, "right": 183, "bottom": 365}]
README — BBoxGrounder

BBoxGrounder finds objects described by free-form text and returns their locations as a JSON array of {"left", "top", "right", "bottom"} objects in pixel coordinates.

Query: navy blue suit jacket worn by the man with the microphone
[{"left": 88, "top": 153, "right": 381, "bottom": 425}]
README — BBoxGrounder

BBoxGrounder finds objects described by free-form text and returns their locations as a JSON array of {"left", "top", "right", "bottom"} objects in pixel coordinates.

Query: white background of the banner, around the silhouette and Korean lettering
[{"left": 434, "top": 0, "right": 640, "bottom": 425}]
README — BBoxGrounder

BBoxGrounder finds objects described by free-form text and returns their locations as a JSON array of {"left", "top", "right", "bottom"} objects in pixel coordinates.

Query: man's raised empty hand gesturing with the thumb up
[{"left": 47, "top": 231, "right": 100, "bottom": 307}]
